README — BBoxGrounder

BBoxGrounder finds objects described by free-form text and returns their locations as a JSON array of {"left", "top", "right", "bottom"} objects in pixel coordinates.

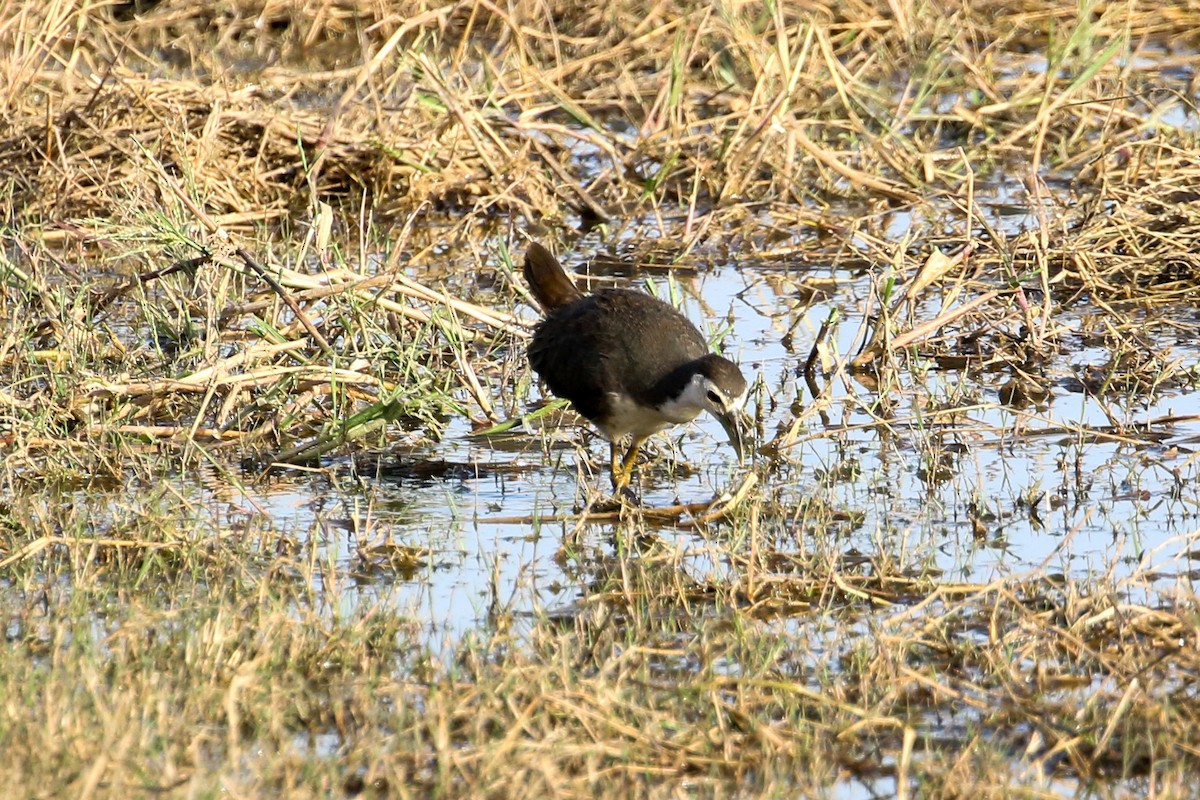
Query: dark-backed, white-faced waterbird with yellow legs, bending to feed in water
[{"left": 522, "top": 242, "right": 749, "bottom": 492}]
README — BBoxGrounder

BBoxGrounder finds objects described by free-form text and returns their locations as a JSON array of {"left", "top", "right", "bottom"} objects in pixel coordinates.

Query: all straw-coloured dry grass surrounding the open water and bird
[{"left": 0, "top": 0, "right": 1200, "bottom": 798}]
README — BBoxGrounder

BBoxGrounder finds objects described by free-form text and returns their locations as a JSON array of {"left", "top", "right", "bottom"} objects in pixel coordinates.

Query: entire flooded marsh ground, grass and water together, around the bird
[{"left": 11, "top": 2, "right": 1200, "bottom": 799}]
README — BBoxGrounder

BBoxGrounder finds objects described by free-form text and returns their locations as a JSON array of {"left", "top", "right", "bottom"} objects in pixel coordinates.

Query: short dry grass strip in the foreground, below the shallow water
[{"left": 9, "top": 498, "right": 1200, "bottom": 796}]
